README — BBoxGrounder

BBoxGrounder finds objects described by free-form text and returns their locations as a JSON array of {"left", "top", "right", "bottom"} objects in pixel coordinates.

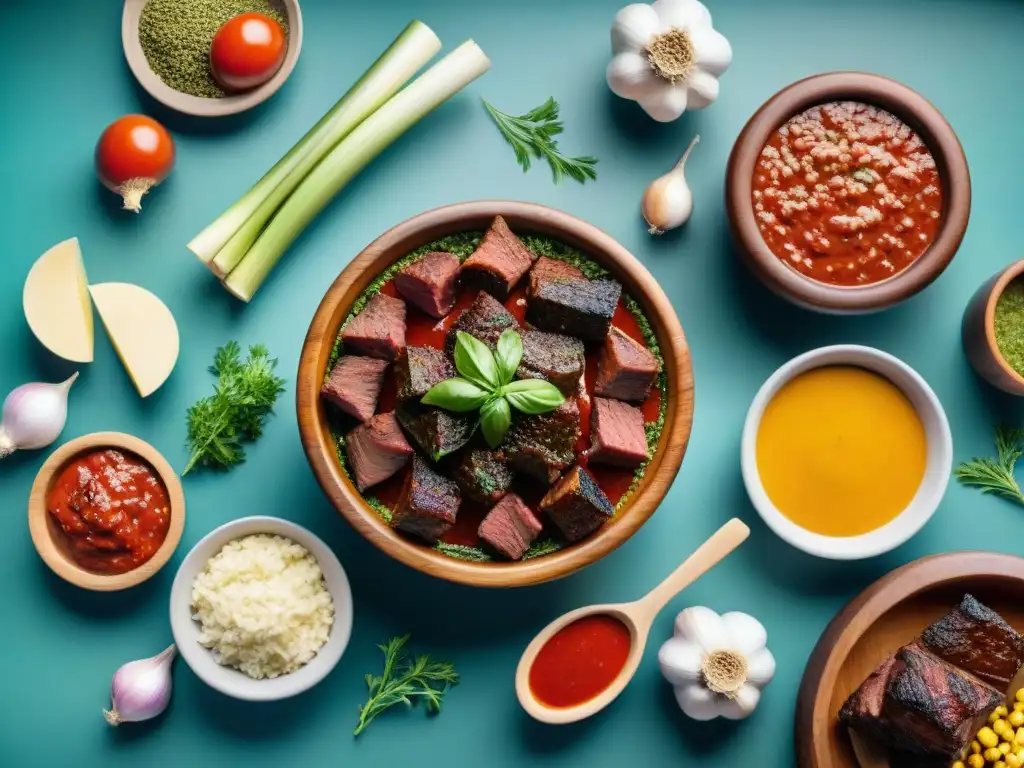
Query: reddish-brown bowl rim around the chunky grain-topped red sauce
[{"left": 725, "top": 72, "right": 971, "bottom": 314}]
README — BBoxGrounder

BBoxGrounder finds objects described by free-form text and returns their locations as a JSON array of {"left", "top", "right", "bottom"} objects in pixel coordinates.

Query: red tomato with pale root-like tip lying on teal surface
[{"left": 96, "top": 115, "right": 174, "bottom": 213}]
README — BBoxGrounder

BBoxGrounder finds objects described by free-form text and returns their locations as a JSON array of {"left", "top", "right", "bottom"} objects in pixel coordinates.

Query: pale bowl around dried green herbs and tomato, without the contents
[{"left": 121, "top": 0, "right": 302, "bottom": 118}]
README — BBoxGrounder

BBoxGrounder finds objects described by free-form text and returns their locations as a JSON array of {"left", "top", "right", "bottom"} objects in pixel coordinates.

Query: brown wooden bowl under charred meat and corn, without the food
[{"left": 795, "top": 552, "right": 1024, "bottom": 768}]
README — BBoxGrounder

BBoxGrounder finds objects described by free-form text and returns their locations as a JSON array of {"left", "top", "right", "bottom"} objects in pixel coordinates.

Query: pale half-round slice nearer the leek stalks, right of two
[{"left": 89, "top": 283, "right": 178, "bottom": 397}]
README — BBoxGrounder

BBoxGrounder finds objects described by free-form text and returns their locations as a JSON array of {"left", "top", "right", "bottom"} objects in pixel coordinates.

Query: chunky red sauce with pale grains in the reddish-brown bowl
[{"left": 753, "top": 101, "right": 943, "bottom": 286}]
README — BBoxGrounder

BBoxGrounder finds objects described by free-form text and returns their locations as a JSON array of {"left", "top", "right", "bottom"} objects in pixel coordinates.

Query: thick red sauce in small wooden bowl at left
[{"left": 46, "top": 449, "right": 171, "bottom": 574}]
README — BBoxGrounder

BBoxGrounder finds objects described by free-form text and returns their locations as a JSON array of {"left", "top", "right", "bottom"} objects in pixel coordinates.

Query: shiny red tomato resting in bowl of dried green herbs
[{"left": 210, "top": 13, "right": 288, "bottom": 91}]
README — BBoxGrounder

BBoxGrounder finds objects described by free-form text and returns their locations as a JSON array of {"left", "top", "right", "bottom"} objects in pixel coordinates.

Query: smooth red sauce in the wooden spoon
[{"left": 529, "top": 613, "right": 632, "bottom": 708}]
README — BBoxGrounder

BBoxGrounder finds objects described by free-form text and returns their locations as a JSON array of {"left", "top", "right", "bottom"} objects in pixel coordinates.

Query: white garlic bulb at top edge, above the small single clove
[{"left": 605, "top": 0, "right": 732, "bottom": 123}]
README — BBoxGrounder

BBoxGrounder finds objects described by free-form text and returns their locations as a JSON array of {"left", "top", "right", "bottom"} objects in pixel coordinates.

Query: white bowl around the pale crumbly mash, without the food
[{"left": 171, "top": 517, "right": 352, "bottom": 701}]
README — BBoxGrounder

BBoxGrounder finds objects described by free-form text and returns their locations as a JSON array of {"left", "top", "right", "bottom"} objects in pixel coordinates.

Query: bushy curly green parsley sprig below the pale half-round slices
[{"left": 181, "top": 341, "right": 285, "bottom": 475}]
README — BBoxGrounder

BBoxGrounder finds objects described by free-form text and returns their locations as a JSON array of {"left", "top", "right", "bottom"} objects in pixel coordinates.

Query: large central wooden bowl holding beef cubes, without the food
[{"left": 296, "top": 201, "right": 693, "bottom": 587}]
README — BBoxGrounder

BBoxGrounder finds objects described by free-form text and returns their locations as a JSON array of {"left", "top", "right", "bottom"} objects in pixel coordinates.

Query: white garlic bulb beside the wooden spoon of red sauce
[{"left": 657, "top": 606, "right": 775, "bottom": 720}]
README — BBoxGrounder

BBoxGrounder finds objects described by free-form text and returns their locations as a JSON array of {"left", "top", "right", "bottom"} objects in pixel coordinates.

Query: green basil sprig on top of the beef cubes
[{"left": 420, "top": 329, "right": 565, "bottom": 449}]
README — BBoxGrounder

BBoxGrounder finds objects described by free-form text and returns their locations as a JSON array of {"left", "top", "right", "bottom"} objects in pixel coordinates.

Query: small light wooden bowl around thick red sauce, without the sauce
[{"left": 29, "top": 432, "right": 185, "bottom": 592}]
